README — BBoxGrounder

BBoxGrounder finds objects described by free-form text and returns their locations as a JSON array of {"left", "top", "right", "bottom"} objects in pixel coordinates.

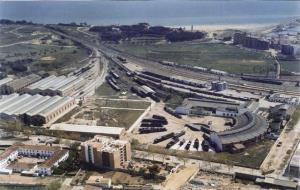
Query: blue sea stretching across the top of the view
[{"left": 0, "top": 0, "right": 300, "bottom": 26}]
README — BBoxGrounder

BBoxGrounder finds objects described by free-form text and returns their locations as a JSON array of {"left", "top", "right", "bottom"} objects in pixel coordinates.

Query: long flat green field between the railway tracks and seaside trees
[{"left": 114, "top": 41, "right": 274, "bottom": 73}]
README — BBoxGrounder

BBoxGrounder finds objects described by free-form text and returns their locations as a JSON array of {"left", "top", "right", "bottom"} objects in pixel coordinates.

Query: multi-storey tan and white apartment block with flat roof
[{"left": 80, "top": 136, "right": 131, "bottom": 169}]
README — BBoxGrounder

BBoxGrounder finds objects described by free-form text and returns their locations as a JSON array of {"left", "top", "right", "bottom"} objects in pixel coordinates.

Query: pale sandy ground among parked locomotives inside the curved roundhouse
[{"left": 128, "top": 103, "right": 228, "bottom": 146}]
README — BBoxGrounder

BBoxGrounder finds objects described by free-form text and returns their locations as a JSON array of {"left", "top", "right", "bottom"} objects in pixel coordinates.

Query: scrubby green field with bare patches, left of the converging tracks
[{"left": 0, "top": 25, "right": 90, "bottom": 74}]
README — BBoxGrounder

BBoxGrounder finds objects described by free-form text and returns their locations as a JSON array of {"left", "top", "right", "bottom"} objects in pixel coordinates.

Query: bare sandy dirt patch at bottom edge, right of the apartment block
[{"left": 162, "top": 166, "right": 199, "bottom": 190}]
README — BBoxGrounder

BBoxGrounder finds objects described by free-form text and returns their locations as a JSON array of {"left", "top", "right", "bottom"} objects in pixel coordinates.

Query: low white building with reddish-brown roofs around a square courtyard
[{"left": 0, "top": 144, "right": 69, "bottom": 176}]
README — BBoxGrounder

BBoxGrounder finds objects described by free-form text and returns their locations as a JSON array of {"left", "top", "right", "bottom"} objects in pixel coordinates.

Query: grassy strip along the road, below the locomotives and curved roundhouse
[{"left": 133, "top": 140, "right": 273, "bottom": 169}]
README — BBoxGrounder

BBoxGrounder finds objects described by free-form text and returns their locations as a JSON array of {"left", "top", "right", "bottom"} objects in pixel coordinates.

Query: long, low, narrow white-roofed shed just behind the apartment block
[{"left": 50, "top": 123, "right": 125, "bottom": 139}]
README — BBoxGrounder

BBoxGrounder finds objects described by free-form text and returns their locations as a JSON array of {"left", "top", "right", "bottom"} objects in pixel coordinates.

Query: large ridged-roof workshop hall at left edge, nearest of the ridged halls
[{"left": 0, "top": 94, "right": 77, "bottom": 126}]
